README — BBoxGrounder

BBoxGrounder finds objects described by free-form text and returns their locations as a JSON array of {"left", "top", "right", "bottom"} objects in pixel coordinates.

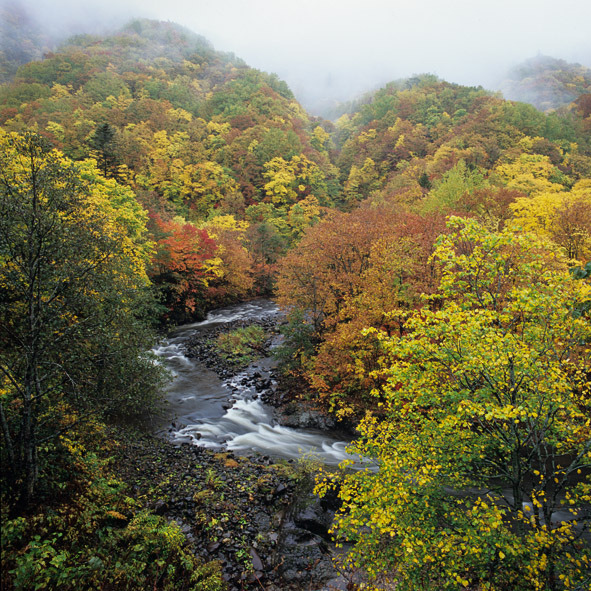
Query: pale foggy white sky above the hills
[{"left": 8, "top": 0, "right": 591, "bottom": 112}]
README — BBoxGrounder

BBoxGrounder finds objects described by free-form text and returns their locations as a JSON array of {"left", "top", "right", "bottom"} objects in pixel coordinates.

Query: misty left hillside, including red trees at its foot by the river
[{"left": 0, "top": 21, "right": 339, "bottom": 319}]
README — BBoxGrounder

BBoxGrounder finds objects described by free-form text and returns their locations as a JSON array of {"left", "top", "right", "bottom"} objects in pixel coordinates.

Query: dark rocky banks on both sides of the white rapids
[{"left": 145, "top": 311, "right": 366, "bottom": 591}]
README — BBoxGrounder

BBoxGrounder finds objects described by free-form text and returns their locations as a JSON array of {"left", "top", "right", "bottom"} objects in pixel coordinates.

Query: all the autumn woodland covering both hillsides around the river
[{"left": 0, "top": 15, "right": 591, "bottom": 591}]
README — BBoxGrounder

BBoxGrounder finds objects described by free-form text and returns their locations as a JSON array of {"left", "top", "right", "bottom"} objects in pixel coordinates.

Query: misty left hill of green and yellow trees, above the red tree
[{"left": 0, "top": 20, "right": 335, "bottom": 219}]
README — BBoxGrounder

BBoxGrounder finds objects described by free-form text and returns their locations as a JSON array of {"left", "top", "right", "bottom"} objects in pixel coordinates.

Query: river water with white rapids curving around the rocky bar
[{"left": 154, "top": 300, "right": 350, "bottom": 465}]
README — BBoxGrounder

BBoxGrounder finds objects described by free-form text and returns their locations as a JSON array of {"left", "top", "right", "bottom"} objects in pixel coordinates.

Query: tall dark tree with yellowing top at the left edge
[{"left": 0, "top": 133, "right": 160, "bottom": 505}]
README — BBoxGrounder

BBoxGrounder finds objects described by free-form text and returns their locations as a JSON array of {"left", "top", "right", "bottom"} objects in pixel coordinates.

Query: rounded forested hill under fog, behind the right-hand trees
[{"left": 335, "top": 76, "right": 591, "bottom": 211}]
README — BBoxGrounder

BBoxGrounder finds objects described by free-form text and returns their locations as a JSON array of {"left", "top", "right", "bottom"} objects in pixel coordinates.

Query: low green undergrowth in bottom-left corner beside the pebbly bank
[{"left": 2, "top": 435, "right": 224, "bottom": 591}]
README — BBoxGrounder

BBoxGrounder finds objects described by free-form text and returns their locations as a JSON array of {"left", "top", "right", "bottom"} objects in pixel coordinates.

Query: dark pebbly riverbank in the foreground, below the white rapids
[{"left": 105, "top": 430, "right": 353, "bottom": 591}]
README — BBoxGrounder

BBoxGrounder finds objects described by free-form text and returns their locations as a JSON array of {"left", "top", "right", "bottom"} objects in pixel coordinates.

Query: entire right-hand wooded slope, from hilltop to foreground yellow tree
[{"left": 278, "top": 76, "right": 591, "bottom": 591}]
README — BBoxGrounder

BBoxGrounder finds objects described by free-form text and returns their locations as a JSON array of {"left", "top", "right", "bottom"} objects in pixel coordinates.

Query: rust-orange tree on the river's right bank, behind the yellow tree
[{"left": 277, "top": 208, "right": 441, "bottom": 415}]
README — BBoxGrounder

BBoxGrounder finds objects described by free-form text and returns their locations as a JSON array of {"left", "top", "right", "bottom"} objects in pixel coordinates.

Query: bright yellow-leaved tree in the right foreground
[{"left": 320, "top": 218, "right": 591, "bottom": 590}]
